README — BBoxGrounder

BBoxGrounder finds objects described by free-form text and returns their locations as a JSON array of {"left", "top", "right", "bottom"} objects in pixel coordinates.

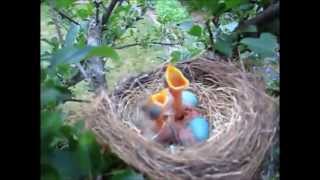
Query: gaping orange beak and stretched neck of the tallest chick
[{"left": 165, "top": 64, "right": 190, "bottom": 119}]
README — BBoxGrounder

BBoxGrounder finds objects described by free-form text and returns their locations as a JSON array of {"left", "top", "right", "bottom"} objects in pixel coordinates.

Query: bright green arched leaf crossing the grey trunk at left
[{"left": 88, "top": 46, "right": 120, "bottom": 61}]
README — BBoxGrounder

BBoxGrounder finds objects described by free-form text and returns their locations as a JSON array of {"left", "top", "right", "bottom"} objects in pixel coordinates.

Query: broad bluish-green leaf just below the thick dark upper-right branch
[{"left": 240, "top": 33, "right": 279, "bottom": 58}]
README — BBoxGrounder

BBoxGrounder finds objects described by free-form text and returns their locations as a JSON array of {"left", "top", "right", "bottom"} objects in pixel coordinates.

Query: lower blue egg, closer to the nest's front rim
[{"left": 187, "top": 116, "right": 209, "bottom": 142}]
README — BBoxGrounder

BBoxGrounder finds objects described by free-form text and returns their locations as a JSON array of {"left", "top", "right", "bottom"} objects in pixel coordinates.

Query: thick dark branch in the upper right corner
[{"left": 237, "top": 1, "right": 280, "bottom": 29}]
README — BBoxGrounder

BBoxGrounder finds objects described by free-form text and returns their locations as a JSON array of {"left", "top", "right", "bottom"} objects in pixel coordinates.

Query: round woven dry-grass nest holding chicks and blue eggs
[{"left": 87, "top": 59, "right": 278, "bottom": 180}]
